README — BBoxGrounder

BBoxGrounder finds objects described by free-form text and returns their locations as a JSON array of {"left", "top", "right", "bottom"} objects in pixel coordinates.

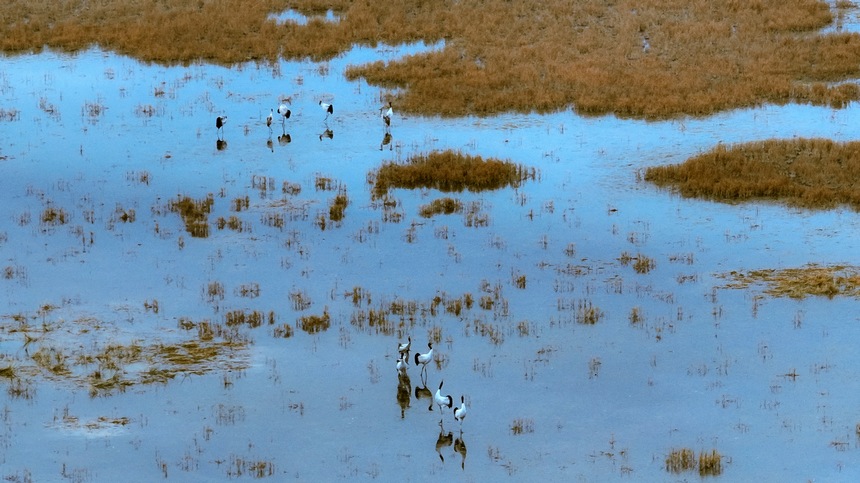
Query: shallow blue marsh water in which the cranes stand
[{"left": 0, "top": 28, "right": 860, "bottom": 481}]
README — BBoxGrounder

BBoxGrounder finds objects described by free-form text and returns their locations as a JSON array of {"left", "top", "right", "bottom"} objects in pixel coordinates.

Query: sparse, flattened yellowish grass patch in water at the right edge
[{"left": 719, "top": 265, "right": 860, "bottom": 299}]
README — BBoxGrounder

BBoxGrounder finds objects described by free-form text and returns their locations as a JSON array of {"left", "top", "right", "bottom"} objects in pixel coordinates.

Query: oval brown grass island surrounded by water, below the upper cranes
[{"left": 373, "top": 150, "right": 536, "bottom": 198}]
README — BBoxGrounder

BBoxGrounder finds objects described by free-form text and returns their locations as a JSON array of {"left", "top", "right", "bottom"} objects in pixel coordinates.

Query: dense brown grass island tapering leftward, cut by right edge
[{"left": 645, "top": 139, "right": 860, "bottom": 210}]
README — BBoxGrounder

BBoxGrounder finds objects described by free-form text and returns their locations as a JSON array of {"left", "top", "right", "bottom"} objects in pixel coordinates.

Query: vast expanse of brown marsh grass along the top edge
[{"left": 0, "top": 0, "right": 860, "bottom": 118}]
